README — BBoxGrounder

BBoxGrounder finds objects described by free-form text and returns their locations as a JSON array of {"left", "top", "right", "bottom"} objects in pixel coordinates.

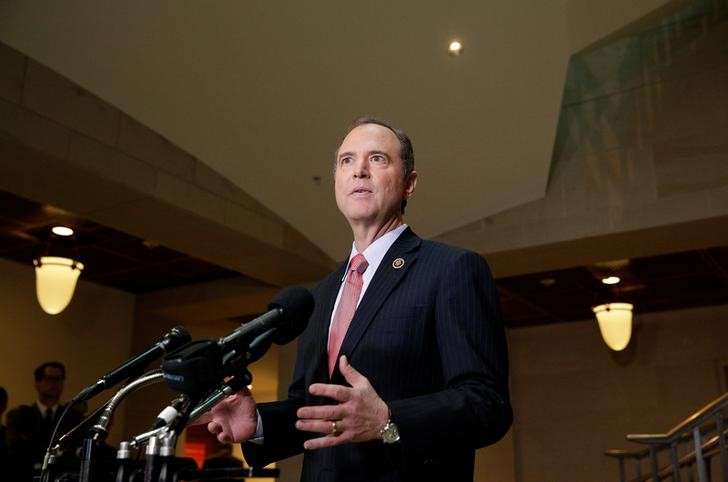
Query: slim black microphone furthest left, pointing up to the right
[{"left": 74, "top": 325, "right": 191, "bottom": 401}]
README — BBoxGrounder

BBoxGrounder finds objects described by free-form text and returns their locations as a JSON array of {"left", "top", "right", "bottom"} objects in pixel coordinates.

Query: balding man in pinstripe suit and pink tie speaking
[{"left": 199, "top": 119, "right": 512, "bottom": 482}]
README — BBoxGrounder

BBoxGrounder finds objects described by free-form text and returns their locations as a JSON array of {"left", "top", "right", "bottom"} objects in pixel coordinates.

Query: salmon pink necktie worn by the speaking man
[{"left": 329, "top": 253, "right": 369, "bottom": 375}]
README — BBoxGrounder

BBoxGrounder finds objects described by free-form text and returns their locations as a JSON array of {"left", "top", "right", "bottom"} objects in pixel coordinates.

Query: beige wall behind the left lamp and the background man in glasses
[{"left": 0, "top": 260, "right": 134, "bottom": 442}]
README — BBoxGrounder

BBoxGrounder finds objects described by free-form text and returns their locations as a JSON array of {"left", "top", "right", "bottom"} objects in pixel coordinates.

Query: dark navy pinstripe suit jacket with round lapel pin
[{"left": 243, "top": 228, "right": 512, "bottom": 482}]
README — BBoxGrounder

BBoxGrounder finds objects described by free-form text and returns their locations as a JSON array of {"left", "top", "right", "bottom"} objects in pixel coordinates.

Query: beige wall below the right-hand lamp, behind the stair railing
[{"left": 508, "top": 306, "right": 728, "bottom": 482}]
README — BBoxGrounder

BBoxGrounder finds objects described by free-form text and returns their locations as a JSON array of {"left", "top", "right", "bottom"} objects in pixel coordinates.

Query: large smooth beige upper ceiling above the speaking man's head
[{"left": 0, "top": 0, "right": 684, "bottom": 259}]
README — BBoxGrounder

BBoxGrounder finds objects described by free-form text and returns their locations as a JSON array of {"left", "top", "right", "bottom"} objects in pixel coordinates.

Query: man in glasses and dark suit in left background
[{"left": 7, "top": 362, "right": 83, "bottom": 481}]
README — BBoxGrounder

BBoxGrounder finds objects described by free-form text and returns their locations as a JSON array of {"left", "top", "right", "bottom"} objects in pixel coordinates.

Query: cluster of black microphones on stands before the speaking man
[{"left": 40, "top": 287, "right": 314, "bottom": 482}]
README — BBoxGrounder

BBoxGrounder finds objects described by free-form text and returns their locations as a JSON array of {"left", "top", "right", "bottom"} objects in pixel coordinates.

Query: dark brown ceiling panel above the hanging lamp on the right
[{"left": 497, "top": 246, "right": 728, "bottom": 328}]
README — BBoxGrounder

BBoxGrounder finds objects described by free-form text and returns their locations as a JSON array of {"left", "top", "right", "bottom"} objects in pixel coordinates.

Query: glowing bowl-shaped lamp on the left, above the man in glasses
[{"left": 33, "top": 228, "right": 83, "bottom": 315}]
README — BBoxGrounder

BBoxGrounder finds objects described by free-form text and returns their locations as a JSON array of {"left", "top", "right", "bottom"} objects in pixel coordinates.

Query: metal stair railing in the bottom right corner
[{"left": 605, "top": 393, "right": 728, "bottom": 482}]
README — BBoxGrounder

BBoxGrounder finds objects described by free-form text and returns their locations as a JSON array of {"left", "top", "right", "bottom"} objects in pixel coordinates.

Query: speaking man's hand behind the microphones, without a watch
[{"left": 192, "top": 389, "right": 258, "bottom": 443}]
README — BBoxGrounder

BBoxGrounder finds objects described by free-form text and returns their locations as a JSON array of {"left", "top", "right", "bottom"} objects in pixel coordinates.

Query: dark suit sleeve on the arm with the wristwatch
[{"left": 389, "top": 252, "right": 513, "bottom": 460}]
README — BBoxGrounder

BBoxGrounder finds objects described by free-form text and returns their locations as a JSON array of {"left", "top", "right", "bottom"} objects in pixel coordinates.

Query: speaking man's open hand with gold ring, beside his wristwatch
[{"left": 296, "top": 356, "right": 389, "bottom": 450}]
